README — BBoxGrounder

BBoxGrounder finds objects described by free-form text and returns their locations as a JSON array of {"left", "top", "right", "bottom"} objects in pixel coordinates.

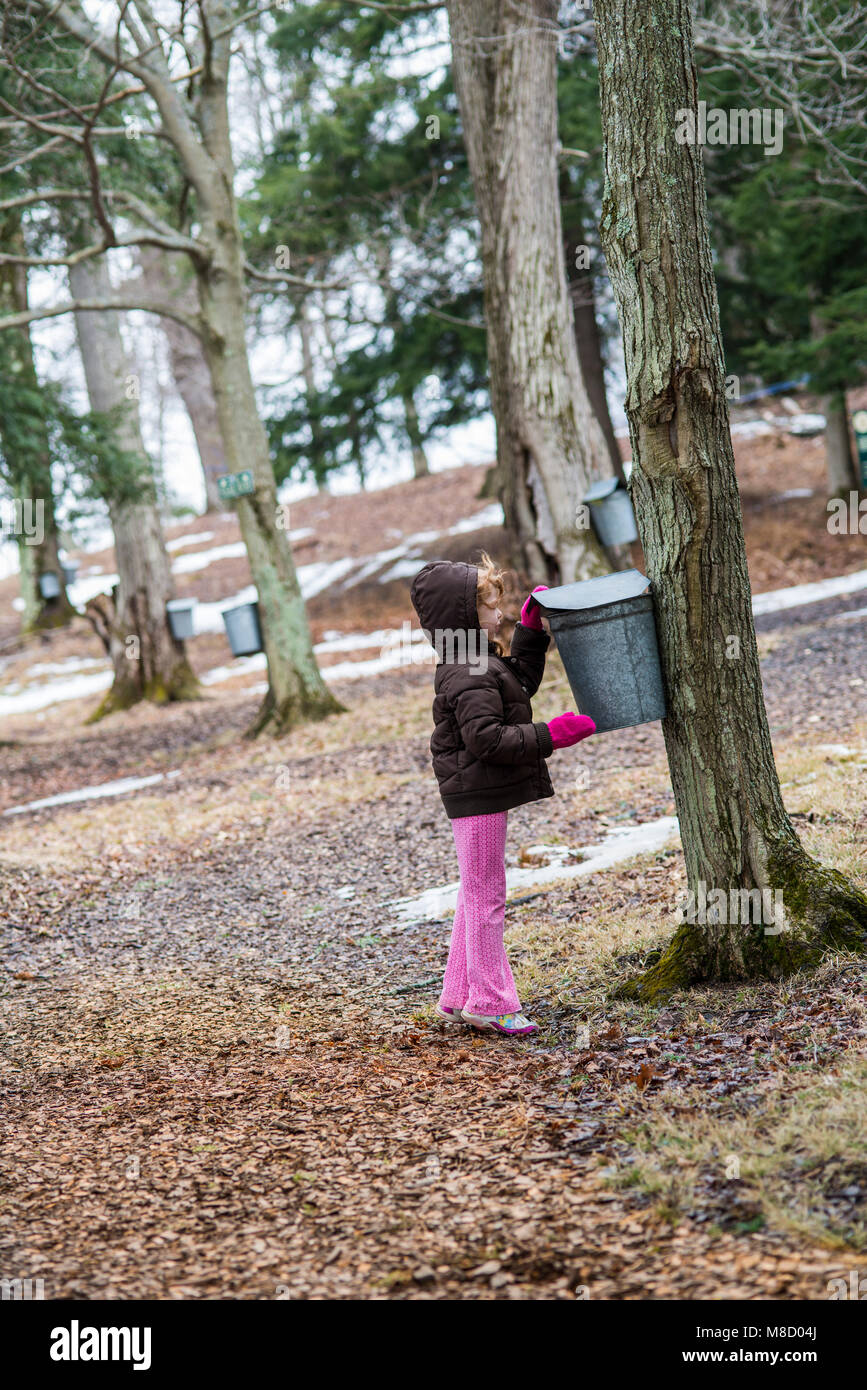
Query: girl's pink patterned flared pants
[{"left": 439, "top": 810, "right": 521, "bottom": 1015}]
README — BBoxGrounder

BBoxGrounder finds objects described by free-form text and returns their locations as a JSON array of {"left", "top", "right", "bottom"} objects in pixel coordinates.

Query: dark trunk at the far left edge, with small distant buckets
[{"left": 0, "top": 210, "right": 75, "bottom": 632}]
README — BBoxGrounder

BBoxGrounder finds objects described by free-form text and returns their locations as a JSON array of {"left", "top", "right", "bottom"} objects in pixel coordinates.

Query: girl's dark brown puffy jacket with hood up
[{"left": 411, "top": 560, "right": 554, "bottom": 820}]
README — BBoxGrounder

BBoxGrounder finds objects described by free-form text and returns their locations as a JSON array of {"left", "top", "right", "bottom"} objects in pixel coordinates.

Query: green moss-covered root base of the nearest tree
[{"left": 614, "top": 841, "right": 867, "bottom": 1004}]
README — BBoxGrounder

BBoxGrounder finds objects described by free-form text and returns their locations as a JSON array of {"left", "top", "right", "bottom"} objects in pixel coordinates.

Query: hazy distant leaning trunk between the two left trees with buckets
[{"left": 139, "top": 246, "right": 226, "bottom": 512}]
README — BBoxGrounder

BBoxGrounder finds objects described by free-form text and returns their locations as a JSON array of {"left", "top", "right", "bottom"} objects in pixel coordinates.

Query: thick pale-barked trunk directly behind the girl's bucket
[{"left": 447, "top": 0, "right": 611, "bottom": 582}]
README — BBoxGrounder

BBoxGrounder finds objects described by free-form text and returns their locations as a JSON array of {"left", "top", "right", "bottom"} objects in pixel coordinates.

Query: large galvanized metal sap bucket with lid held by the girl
[{"left": 536, "top": 570, "right": 666, "bottom": 733}]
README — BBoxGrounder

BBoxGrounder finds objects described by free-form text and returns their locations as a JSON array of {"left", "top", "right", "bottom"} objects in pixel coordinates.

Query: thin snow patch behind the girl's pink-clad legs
[{"left": 389, "top": 816, "right": 679, "bottom": 931}]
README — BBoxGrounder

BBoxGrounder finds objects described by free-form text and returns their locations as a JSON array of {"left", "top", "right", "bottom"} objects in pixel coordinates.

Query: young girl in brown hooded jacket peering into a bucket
[{"left": 411, "top": 553, "right": 596, "bottom": 1037}]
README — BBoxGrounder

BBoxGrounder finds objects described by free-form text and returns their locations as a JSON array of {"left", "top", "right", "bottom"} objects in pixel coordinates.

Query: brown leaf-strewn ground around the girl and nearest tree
[{"left": 0, "top": 567, "right": 867, "bottom": 1300}]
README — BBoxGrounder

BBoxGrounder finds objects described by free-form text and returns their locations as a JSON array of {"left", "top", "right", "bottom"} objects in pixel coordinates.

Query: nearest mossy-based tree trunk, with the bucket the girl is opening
[{"left": 595, "top": 0, "right": 867, "bottom": 999}]
